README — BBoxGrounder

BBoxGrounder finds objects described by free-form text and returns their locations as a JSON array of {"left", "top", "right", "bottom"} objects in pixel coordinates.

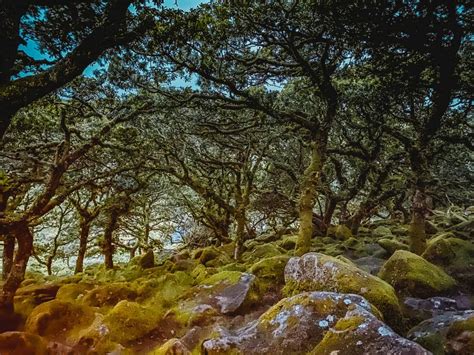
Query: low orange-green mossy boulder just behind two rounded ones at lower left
[{"left": 83, "top": 282, "right": 138, "bottom": 307}]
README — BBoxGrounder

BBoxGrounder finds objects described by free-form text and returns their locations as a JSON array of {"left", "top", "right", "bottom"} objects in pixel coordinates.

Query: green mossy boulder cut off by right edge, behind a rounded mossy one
[{"left": 422, "top": 233, "right": 474, "bottom": 290}]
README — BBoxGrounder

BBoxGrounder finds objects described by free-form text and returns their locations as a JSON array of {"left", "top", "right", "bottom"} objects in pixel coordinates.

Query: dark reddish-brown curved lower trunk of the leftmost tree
[{"left": 0, "top": 222, "right": 33, "bottom": 313}]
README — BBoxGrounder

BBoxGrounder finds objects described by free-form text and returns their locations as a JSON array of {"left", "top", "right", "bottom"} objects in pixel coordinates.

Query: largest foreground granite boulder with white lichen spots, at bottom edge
[{"left": 202, "top": 292, "right": 429, "bottom": 355}]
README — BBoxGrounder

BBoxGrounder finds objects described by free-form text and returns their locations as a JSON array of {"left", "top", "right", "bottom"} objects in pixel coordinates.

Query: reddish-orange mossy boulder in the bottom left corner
[{"left": 0, "top": 332, "right": 50, "bottom": 355}]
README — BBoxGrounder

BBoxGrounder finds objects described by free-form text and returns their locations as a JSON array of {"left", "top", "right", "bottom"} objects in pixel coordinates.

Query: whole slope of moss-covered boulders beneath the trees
[{"left": 0, "top": 211, "right": 474, "bottom": 355}]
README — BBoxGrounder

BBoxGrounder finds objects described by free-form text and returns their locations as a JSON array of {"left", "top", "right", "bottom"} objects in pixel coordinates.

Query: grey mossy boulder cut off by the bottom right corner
[{"left": 407, "top": 310, "right": 474, "bottom": 355}]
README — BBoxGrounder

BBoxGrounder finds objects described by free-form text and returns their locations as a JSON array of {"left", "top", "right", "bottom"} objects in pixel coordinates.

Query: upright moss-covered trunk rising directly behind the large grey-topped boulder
[{"left": 296, "top": 140, "right": 324, "bottom": 255}]
